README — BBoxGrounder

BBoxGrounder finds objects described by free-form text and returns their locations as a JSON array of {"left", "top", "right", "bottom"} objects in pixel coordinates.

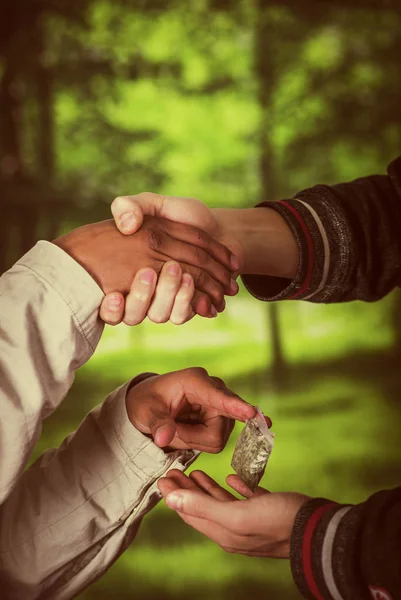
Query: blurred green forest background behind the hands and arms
[{"left": 0, "top": 0, "right": 401, "bottom": 600}]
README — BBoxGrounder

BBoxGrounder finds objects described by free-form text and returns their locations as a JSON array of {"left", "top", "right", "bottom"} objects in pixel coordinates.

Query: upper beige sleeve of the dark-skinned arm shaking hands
[{"left": 0, "top": 242, "right": 103, "bottom": 504}]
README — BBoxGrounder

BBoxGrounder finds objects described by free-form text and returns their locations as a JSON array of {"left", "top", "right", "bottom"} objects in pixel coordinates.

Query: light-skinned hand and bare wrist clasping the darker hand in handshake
[{"left": 100, "top": 192, "right": 299, "bottom": 324}]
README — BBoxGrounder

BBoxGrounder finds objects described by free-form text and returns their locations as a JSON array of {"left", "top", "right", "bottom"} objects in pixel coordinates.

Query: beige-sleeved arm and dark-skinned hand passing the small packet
[{"left": 0, "top": 368, "right": 255, "bottom": 600}]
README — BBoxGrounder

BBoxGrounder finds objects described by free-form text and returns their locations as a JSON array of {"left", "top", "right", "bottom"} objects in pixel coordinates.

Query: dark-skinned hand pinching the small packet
[{"left": 126, "top": 367, "right": 270, "bottom": 453}]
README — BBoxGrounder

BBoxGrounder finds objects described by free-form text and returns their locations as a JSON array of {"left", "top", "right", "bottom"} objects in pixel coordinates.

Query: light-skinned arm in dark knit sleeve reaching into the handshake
[{"left": 112, "top": 158, "right": 401, "bottom": 310}]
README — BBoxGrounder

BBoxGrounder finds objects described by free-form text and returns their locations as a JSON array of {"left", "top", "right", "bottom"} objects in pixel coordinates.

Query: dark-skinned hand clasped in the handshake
[{"left": 54, "top": 216, "right": 238, "bottom": 318}]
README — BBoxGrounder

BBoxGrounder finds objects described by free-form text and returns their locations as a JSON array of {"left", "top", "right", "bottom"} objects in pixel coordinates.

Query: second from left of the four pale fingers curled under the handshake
[{"left": 124, "top": 268, "right": 157, "bottom": 325}]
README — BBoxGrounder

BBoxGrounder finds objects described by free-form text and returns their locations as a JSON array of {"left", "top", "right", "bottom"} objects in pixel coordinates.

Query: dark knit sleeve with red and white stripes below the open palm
[{"left": 291, "top": 488, "right": 401, "bottom": 600}]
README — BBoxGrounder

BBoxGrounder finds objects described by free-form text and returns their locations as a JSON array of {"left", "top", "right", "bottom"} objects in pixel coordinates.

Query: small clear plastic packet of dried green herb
[{"left": 231, "top": 408, "right": 274, "bottom": 492}]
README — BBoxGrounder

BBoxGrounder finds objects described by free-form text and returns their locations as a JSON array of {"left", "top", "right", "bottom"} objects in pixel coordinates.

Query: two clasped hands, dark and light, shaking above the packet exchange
[{"left": 54, "top": 193, "right": 298, "bottom": 325}]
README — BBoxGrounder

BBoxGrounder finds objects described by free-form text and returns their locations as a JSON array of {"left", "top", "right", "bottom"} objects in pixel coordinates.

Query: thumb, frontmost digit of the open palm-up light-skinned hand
[{"left": 165, "top": 490, "right": 237, "bottom": 527}]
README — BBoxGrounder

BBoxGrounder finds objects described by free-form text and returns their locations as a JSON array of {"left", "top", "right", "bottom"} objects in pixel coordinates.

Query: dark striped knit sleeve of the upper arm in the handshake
[{"left": 243, "top": 157, "right": 401, "bottom": 303}]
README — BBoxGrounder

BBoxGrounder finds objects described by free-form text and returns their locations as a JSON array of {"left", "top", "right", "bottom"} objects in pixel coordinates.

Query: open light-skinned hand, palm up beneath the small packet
[{"left": 158, "top": 469, "right": 309, "bottom": 558}]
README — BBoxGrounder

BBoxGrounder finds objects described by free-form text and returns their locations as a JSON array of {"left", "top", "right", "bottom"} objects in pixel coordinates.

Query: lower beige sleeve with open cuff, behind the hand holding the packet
[{"left": 0, "top": 384, "right": 195, "bottom": 600}]
